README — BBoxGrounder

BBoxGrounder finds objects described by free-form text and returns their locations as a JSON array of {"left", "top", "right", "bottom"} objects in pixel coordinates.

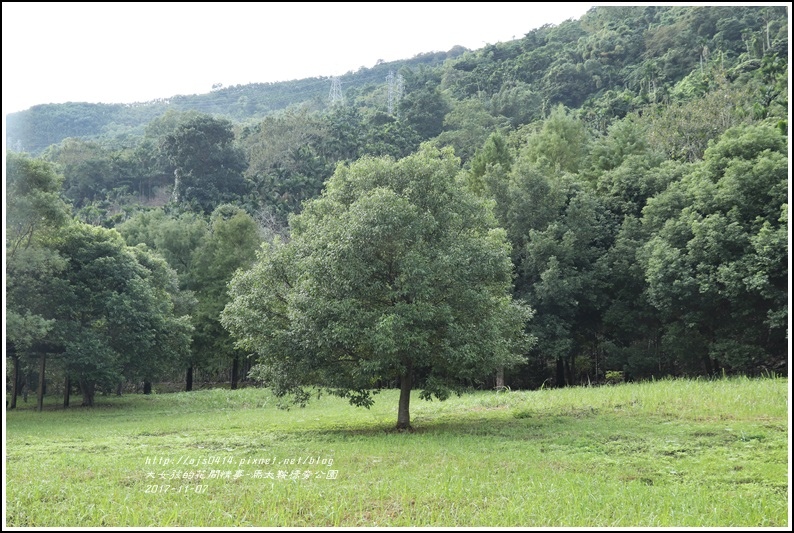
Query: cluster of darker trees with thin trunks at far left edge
[{"left": 6, "top": 154, "right": 192, "bottom": 407}]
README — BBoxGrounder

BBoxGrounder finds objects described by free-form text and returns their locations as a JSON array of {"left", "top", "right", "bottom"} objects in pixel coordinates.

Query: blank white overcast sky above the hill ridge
[{"left": 2, "top": 2, "right": 591, "bottom": 115}]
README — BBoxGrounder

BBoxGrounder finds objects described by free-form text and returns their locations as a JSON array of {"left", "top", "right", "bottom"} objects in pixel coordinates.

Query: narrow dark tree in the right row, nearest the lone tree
[{"left": 517, "top": 178, "right": 615, "bottom": 386}]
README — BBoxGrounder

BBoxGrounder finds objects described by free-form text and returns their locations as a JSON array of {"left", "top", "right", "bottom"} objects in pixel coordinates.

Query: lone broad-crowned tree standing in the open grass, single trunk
[{"left": 221, "top": 146, "right": 529, "bottom": 429}]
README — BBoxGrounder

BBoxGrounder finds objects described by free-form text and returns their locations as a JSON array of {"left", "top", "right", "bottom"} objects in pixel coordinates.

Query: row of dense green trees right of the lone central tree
[{"left": 468, "top": 113, "right": 788, "bottom": 386}]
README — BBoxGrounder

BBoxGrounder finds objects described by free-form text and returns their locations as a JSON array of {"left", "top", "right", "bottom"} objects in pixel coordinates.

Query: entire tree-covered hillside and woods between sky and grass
[{"left": 6, "top": 6, "right": 789, "bottom": 407}]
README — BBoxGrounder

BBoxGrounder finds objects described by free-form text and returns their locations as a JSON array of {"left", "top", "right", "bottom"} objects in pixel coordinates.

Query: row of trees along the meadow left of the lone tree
[{"left": 6, "top": 152, "right": 262, "bottom": 407}]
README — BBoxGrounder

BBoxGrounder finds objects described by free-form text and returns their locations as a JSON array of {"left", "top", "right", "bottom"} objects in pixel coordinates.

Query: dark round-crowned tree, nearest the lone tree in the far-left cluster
[{"left": 46, "top": 222, "right": 191, "bottom": 406}]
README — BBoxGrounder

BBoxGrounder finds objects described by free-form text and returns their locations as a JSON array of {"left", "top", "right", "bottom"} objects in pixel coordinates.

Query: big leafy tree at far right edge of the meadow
[{"left": 638, "top": 124, "right": 789, "bottom": 373}]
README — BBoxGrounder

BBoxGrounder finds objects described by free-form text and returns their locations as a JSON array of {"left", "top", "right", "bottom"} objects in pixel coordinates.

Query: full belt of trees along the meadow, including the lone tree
[{"left": 7, "top": 113, "right": 788, "bottom": 427}]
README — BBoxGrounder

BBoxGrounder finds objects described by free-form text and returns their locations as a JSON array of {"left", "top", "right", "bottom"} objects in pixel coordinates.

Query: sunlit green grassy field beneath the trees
[{"left": 5, "top": 378, "right": 790, "bottom": 528}]
